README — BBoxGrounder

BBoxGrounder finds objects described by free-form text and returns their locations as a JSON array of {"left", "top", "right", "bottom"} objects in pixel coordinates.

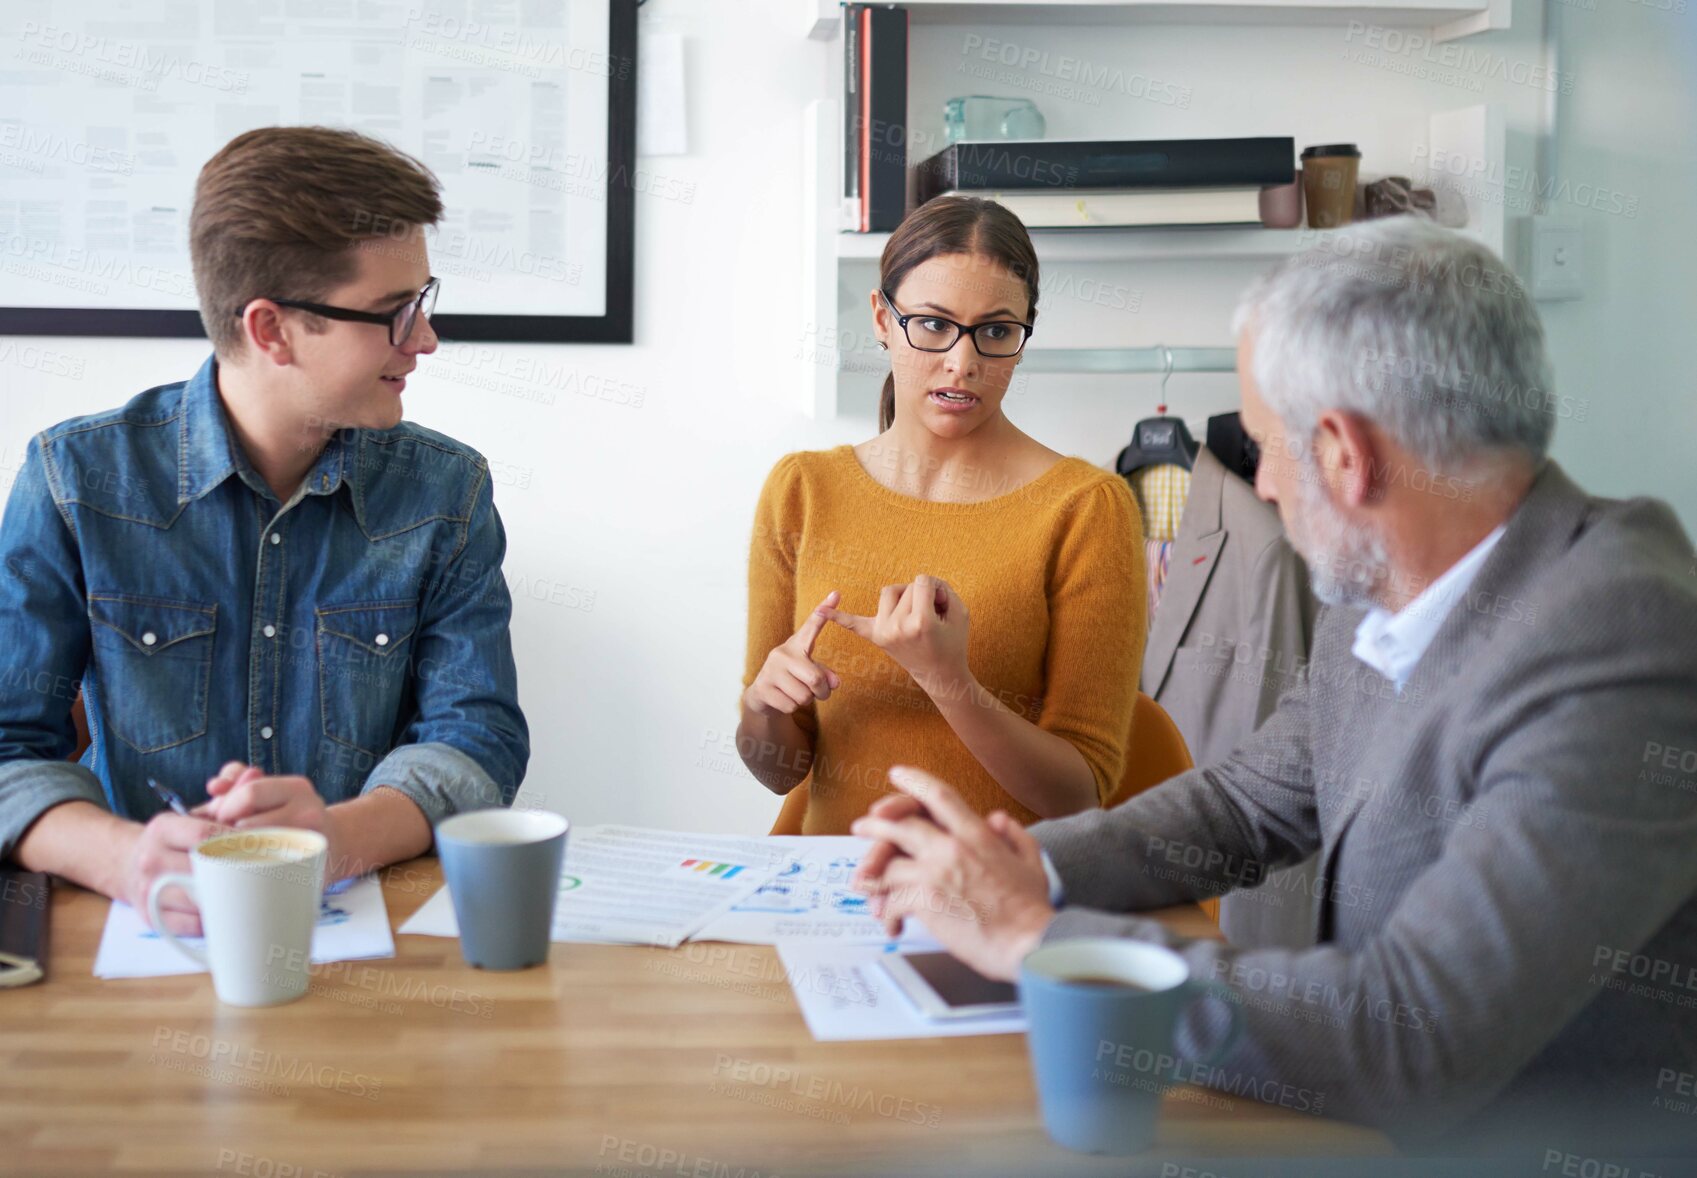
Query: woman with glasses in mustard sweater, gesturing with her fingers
[{"left": 736, "top": 197, "right": 1145, "bottom": 835}]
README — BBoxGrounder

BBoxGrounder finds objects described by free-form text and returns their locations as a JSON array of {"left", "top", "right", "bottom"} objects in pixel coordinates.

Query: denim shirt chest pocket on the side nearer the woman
[{"left": 316, "top": 601, "right": 419, "bottom": 757}]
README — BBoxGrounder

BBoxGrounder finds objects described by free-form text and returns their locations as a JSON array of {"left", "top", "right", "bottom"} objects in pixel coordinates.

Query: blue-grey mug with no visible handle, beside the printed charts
[{"left": 436, "top": 810, "right": 572, "bottom": 969}]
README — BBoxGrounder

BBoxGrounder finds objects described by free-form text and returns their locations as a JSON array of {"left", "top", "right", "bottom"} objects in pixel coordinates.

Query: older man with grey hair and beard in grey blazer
[{"left": 855, "top": 219, "right": 1697, "bottom": 1173}]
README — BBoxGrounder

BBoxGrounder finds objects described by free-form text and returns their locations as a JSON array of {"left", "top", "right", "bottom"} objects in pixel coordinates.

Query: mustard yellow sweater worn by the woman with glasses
[{"left": 743, "top": 446, "right": 1147, "bottom": 835}]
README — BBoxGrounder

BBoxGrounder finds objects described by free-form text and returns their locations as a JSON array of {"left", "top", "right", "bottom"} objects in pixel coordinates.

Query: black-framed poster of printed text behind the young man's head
[{"left": 0, "top": 0, "right": 636, "bottom": 343}]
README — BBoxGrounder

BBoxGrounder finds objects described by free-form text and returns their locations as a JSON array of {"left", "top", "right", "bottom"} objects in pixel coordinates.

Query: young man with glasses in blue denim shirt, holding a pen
[{"left": 0, "top": 127, "right": 529, "bottom": 932}]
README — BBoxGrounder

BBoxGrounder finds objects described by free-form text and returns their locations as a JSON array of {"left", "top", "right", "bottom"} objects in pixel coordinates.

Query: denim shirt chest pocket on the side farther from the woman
[{"left": 88, "top": 592, "right": 217, "bottom": 752}]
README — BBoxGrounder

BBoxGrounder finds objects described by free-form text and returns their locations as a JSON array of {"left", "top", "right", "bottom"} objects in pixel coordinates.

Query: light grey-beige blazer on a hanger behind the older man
[{"left": 1142, "top": 448, "right": 1317, "bottom": 949}]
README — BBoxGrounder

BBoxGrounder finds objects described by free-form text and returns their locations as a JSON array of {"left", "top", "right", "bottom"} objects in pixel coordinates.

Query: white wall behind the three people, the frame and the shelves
[{"left": 0, "top": 0, "right": 1697, "bottom": 830}]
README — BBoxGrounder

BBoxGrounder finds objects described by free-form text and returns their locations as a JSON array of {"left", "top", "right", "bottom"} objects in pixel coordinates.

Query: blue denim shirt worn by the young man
[{"left": 0, "top": 358, "right": 529, "bottom": 859}]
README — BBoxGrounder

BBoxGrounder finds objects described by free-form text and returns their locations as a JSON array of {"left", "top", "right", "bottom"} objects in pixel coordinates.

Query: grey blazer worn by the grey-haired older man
[{"left": 1032, "top": 462, "right": 1697, "bottom": 1156}]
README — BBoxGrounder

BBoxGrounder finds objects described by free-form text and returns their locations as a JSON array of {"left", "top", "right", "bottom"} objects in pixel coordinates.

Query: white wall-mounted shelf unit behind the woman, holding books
[{"left": 796, "top": 0, "right": 1509, "bottom": 419}]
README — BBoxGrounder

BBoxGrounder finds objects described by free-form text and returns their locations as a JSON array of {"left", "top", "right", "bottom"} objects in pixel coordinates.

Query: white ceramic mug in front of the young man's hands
[{"left": 148, "top": 827, "right": 329, "bottom": 1007}]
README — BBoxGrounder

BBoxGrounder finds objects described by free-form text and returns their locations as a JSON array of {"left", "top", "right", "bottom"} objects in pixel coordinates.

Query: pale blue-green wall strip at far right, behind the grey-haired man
[{"left": 1543, "top": 0, "right": 1697, "bottom": 526}]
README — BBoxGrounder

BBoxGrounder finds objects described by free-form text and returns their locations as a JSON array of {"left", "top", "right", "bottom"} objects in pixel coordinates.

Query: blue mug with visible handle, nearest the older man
[{"left": 1020, "top": 937, "right": 1242, "bottom": 1154}]
